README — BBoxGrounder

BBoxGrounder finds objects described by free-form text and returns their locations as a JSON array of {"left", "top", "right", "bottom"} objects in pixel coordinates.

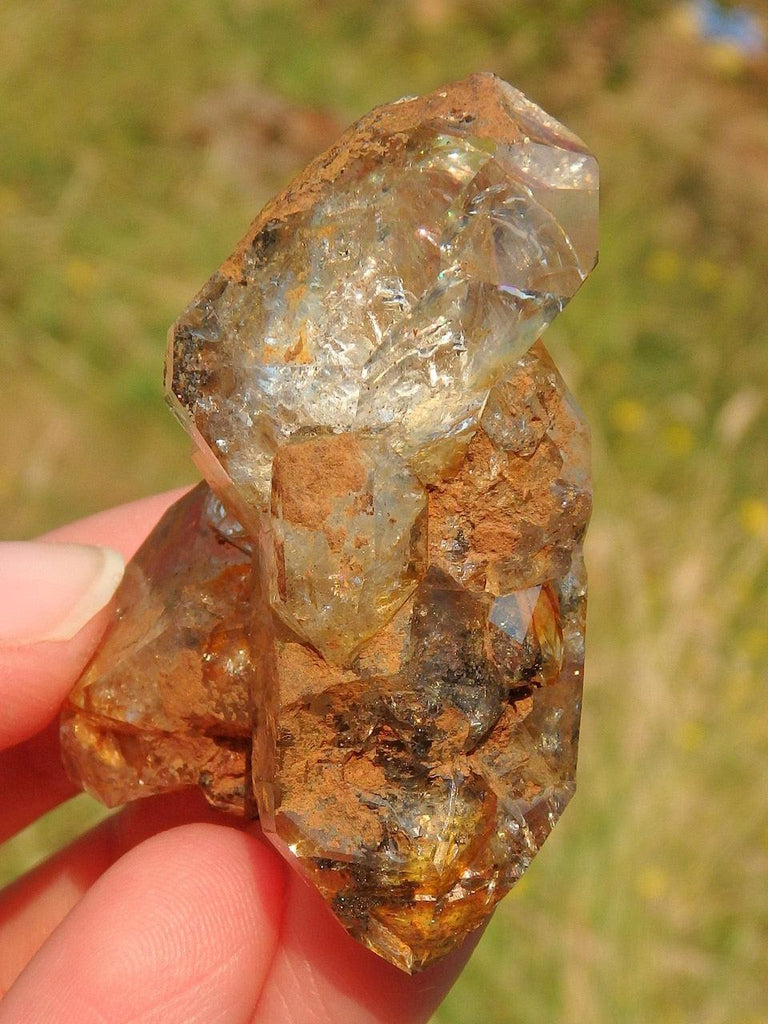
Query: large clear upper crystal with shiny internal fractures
[{"left": 167, "top": 75, "right": 598, "bottom": 519}]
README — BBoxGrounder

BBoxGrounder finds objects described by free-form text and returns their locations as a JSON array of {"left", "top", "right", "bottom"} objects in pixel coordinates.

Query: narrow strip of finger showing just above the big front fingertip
[{"left": 0, "top": 790, "right": 237, "bottom": 997}]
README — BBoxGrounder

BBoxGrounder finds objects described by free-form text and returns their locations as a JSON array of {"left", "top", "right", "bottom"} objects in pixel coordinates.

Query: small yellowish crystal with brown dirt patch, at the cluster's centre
[{"left": 271, "top": 433, "right": 427, "bottom": 664}]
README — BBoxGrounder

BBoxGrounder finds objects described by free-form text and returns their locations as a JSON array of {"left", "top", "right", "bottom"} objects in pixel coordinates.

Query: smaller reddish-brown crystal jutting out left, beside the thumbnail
[{"left": 61, "top": 484, "right": 252, "bottom": 813}]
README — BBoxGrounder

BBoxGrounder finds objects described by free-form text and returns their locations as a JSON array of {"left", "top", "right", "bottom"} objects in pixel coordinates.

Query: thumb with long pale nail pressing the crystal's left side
[{"left": 0, "top": 490, "right": 189, "bottom": 749}]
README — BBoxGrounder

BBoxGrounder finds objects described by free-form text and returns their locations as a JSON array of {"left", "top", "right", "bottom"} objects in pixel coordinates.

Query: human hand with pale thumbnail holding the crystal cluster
[{"left": 0, "top": 492, "right": 473, "bottom": 1024}]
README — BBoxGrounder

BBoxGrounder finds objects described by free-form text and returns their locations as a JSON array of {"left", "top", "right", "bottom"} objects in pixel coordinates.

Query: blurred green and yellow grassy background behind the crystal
[{"left": 0, "top": 0, "right": 768, "bottom": 1024}]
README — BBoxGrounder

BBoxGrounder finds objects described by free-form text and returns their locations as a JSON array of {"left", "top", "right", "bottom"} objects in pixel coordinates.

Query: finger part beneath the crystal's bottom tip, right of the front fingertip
[{"left": 252, "top": 871, "right": 479, "bottom": 1024}]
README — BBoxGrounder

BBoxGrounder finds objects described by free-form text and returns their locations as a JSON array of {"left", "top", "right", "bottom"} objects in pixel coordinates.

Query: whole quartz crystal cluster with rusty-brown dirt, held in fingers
[{"left": 62, "top": 74, "right": 597, "bottom": 971}]
